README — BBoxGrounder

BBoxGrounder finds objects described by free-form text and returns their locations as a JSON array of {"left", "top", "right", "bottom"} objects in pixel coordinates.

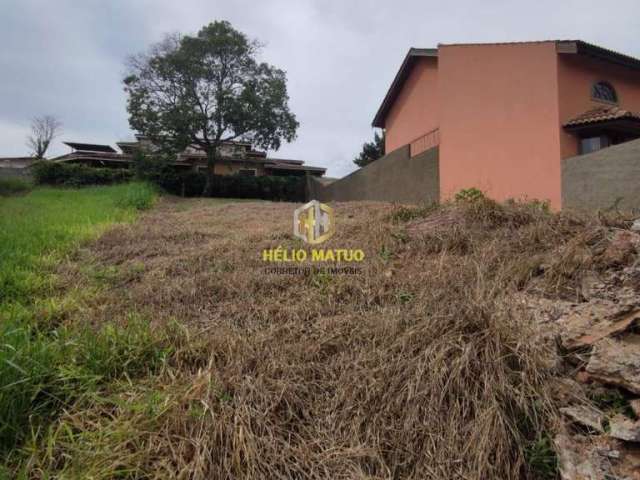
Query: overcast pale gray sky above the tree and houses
[{"left": 0, "top": 0, "right": 640, "bottom": 177}]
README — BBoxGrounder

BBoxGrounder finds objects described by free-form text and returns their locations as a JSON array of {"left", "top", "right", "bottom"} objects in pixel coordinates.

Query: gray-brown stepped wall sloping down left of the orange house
[{"left": 307, "top": 145, "right": 440, "bottom": 203}]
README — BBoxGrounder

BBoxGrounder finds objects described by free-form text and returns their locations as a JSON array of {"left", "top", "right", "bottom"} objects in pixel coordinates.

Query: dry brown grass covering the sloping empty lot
[{"left": 21, "top": 196, "right": 640, "bottom": 479}]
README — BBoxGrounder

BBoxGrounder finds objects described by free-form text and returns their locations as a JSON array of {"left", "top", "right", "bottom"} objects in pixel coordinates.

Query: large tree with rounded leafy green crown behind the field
[{"left": 124, "top": 21, "right": 298, "bottom": 194}]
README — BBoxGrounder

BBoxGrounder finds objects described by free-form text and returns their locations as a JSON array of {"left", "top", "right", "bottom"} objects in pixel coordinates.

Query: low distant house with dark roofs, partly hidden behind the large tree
[{"left": 51, "top": 136, "right": 326, "bottom": 177}]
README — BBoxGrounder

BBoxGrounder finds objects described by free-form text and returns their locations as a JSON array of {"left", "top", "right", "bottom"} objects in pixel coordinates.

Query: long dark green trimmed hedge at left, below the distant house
[{"left": 33, "top": 161, "right": 134, "bottom": 187}]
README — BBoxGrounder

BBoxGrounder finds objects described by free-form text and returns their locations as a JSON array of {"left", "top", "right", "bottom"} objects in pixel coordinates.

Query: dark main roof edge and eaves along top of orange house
[{"left": 372, "top": 40, "right": 640, "bottom": 128}]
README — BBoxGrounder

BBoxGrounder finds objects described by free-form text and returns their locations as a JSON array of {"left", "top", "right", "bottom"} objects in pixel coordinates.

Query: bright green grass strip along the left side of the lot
[{"left": 0, "top": 183, "right": 162, "bottom": 464}]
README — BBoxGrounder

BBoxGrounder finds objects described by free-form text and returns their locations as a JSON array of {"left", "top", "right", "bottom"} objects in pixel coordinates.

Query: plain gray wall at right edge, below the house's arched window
[{"left": 562, "top": 140, "right": 640, "bottom": 211}]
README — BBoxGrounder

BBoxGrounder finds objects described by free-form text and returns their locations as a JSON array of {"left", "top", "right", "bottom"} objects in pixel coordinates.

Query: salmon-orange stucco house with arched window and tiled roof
[{"left": 373, "top": 40, "right": 640, "bottom": 208}]
